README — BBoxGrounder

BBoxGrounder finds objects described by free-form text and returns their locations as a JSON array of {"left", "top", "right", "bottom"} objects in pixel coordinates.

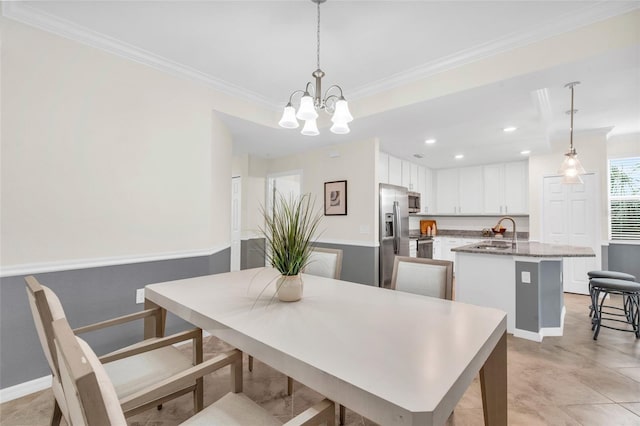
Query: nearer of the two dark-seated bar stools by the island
[{"left": 590, "top": 278, "right": 640, "bottom": 340}]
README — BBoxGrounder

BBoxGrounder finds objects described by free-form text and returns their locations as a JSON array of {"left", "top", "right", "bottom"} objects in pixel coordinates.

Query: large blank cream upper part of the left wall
[{"left": 0, "top": 18, "right": 237, "bottom": 268}]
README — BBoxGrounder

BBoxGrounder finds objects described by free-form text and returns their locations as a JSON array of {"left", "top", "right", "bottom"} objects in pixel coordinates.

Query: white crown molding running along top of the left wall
[{"left": 2, "top": 1, "right": 280, "bottom": 111}]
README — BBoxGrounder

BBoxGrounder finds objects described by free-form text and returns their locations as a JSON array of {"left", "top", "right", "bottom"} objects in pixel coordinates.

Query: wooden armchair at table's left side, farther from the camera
[{"left": 25, "top": 276, "right": 230, "bottom": 425}]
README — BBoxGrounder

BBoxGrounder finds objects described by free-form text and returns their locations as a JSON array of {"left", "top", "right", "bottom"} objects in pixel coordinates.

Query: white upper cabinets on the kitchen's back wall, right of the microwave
[{"left": 436, "top": 161, "right": 529, "bottom": 215}]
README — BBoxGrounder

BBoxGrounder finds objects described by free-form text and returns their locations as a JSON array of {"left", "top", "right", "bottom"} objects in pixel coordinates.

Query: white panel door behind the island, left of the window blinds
[{"left": 542, "top": 174, "right": 601, "bottom": 294}]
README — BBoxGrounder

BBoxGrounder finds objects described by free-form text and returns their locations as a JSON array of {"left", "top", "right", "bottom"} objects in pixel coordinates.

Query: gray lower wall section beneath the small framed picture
[{"left": 316, "top": 243, "right": 379, "bottom": 287}]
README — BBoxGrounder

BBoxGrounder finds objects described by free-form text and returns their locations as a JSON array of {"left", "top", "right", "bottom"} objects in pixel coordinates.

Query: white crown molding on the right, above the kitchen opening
[{"left": 349, "top": 1, "right": 640, "bottom": 99}]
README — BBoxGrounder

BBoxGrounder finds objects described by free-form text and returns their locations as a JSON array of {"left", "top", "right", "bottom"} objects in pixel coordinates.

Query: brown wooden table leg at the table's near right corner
[{"left": 480, "top": 333, "right": 507, "bottom": 426}]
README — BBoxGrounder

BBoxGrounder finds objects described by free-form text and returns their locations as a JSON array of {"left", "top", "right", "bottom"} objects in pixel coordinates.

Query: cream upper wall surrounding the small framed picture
[{"left": 267, "top": 139, "right": 378, "bottom": 246}]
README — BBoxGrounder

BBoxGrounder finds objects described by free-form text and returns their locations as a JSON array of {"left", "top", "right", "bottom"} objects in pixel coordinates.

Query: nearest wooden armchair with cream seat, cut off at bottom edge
[{"left": 53, "top": 318, "right": 335, "bottom": 426}]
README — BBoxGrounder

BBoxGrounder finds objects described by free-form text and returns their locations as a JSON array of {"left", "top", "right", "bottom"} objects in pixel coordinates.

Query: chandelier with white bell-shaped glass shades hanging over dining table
[{"left": 278, "top": 0, "right": 353, "bottom": 136}]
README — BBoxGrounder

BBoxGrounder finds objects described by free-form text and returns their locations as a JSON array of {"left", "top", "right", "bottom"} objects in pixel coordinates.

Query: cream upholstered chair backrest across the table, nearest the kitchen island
[{"left": 391, "top": 256, "right": 453, "bottom": 300}]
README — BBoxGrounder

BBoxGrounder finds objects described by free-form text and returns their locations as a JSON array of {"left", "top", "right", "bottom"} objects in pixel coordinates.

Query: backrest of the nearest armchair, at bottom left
[{"left": 52, "top": 318, "right": 127, "bottom": 426}]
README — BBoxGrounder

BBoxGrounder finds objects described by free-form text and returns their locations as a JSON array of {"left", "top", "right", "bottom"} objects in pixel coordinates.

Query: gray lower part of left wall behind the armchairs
[{"left": 0, "top": 248, "right": 230, "bottom": 389}]
